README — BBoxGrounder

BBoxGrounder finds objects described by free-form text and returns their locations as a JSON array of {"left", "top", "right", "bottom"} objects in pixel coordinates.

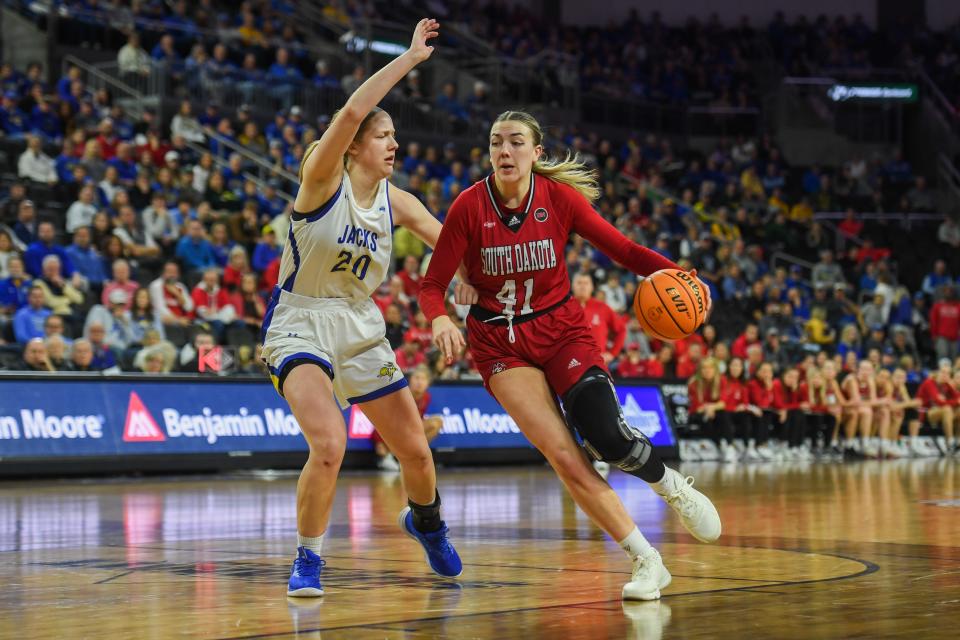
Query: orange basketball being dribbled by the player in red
[{"left": 633, "top": 269, "right": 706, "bottom": 340}]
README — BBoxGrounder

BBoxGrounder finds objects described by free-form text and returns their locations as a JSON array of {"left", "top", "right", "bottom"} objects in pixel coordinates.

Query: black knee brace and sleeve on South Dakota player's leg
[{"left": 563, "top": 367, "right": 653, "bottom": 473}]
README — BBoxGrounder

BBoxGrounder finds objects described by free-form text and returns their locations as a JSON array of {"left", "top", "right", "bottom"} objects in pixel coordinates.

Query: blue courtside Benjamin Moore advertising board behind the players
[{"left": 0, "top": 378, "right": 676, "bottom": 464}]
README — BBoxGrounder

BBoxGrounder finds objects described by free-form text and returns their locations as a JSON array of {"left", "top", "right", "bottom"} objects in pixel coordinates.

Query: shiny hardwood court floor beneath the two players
[{"left": 0, "top": 460, "right": 960, "bottom": 640}]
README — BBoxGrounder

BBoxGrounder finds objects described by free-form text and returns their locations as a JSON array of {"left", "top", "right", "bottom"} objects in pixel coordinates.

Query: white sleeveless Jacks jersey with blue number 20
[{"left": 278, "top": 171, "right": 393, "bottom": 300}]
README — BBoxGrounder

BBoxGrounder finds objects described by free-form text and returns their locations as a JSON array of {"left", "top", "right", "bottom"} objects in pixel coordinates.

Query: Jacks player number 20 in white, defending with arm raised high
[{"left": 261, "top": 19, "right": 476, "bottom": 596}]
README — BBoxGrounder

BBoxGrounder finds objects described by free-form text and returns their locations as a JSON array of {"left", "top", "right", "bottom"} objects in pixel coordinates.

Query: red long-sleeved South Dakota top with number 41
[{"left": 420, "top": 174, "right": 678, "bottom": 322}]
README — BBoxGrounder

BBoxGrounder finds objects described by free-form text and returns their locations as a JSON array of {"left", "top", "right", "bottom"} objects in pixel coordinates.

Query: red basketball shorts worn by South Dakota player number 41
[{"left": 467, "top": 298, "right": 607, "bottom": 396}]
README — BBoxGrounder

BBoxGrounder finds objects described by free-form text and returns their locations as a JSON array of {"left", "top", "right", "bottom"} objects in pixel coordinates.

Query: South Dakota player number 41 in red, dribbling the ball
[{"left": 420, "top": 111, "right": 721, "bottom": 600}]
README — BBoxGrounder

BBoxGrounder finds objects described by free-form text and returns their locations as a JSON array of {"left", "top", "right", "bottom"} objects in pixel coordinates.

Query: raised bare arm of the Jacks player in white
[{"left": 300, "top": 18, "right": 440, "bottom": 195}]
